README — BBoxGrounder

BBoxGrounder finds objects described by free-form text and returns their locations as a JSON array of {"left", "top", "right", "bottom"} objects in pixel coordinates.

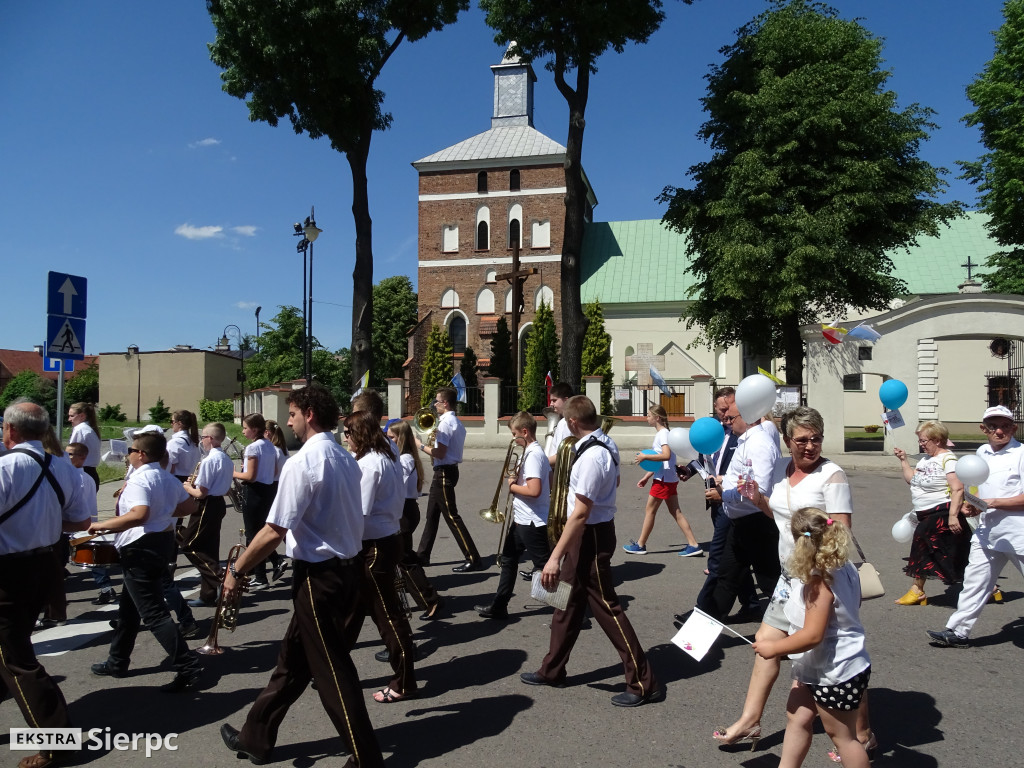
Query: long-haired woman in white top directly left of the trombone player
[{"left": 387, "top": 421, "right": 441, "bottom": 621}]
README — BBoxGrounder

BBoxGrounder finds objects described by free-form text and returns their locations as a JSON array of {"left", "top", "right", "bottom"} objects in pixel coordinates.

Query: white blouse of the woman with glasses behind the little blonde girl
[{"left": 768, "top": 458, "right": 853, "bottom": 569}]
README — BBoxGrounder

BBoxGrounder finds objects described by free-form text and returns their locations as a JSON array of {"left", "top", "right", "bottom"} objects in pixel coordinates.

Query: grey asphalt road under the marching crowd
[{"left": 0, "top": 461, "right": 1024, "bottom": 768}]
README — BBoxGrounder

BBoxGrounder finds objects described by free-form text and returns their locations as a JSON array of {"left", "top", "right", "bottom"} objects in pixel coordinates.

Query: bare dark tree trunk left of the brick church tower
[{"left": 345, "top": 128, "right": 374, "bottom": 392}]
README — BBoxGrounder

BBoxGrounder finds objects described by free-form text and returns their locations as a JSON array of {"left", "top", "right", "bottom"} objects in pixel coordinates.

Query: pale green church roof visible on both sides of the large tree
[{"left": 582, "top": 211, "right": 998, "bottom": 304}]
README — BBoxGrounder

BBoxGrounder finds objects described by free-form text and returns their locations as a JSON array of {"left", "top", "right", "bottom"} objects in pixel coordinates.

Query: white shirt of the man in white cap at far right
[{"left": 970, "top": 438, "right": 1024, "bottom": 555}]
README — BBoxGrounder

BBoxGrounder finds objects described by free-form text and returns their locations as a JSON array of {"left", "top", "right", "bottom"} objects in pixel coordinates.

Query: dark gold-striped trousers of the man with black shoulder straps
[{"left": 538, "top": 520, "right": 655, "bottom": 696}]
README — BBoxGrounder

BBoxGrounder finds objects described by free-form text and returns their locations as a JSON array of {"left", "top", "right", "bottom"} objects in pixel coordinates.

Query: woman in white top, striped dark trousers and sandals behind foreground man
[{"left": 345, "top": 411, "right": 417, "bottom": 703}]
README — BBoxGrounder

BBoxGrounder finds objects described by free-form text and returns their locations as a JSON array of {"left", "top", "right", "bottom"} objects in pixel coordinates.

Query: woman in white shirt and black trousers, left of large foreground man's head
[{"left": 233, "top": 414, "right": 283, "bottom": 590}]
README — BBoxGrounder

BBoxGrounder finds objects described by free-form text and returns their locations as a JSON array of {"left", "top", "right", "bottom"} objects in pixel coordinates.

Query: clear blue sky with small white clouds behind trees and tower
[{"left": 0, "top": 0, "right": 1001, "bottom": 354}]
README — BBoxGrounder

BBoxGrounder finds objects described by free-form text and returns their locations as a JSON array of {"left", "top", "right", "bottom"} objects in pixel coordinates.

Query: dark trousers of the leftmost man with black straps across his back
[{"left": 0, "top": 551, "right": 71, "bottom": 741}]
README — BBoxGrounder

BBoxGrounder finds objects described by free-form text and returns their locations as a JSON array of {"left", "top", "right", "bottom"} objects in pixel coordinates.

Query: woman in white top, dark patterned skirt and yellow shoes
[{"left": 893, "top": 421, "right": 971, "bottom": 605}]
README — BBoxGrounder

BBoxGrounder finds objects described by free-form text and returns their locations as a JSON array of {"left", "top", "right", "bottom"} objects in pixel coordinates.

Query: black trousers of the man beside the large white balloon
[{"left": 708, "top": 512, "right": 782, "bottom": 621}]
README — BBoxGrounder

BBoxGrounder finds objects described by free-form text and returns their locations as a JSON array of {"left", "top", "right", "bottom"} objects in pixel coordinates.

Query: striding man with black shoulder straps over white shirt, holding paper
[{"left": 520, "top": 395, "right": 665, "bottom": 707}]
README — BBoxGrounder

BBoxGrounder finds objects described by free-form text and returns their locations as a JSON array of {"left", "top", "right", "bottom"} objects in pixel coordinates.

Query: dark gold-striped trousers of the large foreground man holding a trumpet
[{"left": 239, "top": 558, "right": 384, "bottom": 768}]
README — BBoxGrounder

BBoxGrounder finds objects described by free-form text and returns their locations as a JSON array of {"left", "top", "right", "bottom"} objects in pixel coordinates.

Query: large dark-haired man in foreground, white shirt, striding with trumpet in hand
[{"left": 220, "top": 384, "right": 384, "bottom": 768}]
